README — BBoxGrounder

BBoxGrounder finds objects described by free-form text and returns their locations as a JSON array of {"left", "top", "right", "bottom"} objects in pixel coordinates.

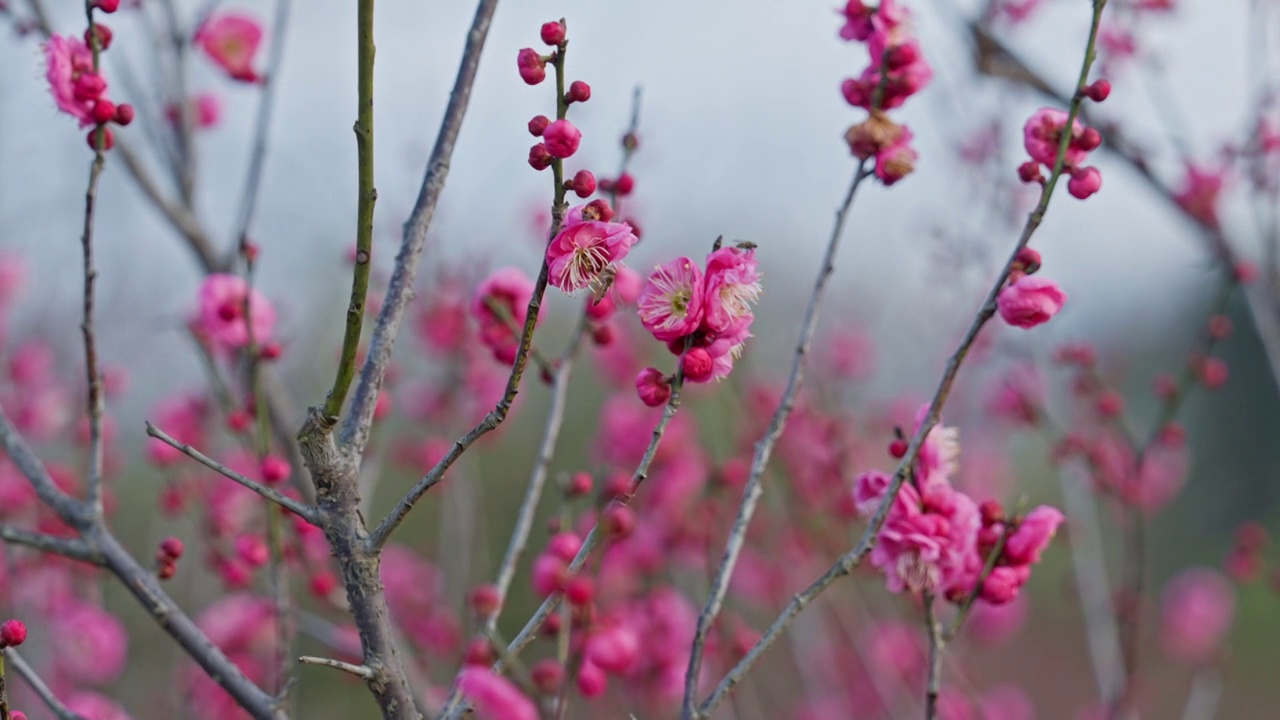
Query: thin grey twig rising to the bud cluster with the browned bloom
[{"left": 681, "top": 160, "right": 870, "bottom": 719}]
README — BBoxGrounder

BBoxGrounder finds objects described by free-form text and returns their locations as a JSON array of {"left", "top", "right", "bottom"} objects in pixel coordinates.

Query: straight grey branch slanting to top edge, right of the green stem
[{"left": 340, "top": 0, "right": 498, "bottom": 456}]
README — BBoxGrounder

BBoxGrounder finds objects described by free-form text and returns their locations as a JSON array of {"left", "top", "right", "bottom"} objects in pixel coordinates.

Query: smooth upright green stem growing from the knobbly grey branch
[{"left": 324, "top": 0, "right": 378, "bottom": 420}]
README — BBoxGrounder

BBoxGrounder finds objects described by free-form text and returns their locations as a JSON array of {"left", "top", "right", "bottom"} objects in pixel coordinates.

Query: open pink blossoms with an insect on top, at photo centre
[{"left": 636, "top": 245, "right": 760, "bottom": 397}]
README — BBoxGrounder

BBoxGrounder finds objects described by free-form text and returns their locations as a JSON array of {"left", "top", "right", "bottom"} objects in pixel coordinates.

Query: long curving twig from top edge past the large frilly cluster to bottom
[{"left": 698, "top": 0, "right": 1106, "bottom": 716}]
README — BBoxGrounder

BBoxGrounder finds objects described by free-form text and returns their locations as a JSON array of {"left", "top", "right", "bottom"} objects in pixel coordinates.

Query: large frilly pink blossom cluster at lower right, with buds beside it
[{"left": 854, "top": 407, "right": 1062, "bottom": 605}]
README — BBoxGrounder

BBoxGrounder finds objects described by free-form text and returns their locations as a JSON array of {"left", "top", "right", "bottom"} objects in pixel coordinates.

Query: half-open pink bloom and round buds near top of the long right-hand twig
[{"left": 1018, "top": 99, "right": 1111, "bottom": 200}]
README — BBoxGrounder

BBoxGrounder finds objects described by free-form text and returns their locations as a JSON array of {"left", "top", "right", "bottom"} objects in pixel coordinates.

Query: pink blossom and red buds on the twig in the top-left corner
[{"left": 45, "top": 0, "right": 134, "bottom": 150}]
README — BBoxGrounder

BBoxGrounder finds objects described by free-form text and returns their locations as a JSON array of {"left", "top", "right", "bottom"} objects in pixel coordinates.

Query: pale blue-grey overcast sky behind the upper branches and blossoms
[{"left": 0, "top": 0, "right": 1251, "bottom": 409}]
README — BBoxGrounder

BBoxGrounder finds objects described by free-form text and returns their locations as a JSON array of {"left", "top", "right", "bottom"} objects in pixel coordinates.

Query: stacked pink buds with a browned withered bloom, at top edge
[{"left": 840, "top": 0, "right": 933, "bottom": 186}]
